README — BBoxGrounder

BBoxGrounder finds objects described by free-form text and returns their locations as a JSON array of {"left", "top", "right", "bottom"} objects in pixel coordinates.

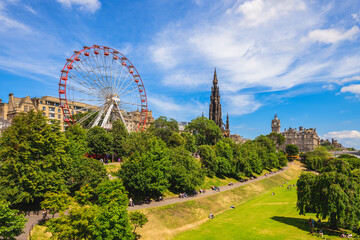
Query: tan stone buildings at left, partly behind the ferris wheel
[{"left": 0, "top": 93, "right": 154, "bottom": 131}]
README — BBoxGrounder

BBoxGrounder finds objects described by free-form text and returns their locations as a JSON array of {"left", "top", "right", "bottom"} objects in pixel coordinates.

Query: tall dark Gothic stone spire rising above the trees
[{"left": 209, "top": 69, "right": 230, "bottom": 137}]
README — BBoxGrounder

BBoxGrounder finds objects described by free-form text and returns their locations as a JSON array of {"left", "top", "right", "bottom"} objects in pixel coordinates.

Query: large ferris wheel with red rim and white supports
[{"left": 59, "top": 45, "right": 148, "bottom": 132}]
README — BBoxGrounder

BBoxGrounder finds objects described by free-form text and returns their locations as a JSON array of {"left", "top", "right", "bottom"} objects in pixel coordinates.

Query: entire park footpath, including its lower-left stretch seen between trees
[{"left": 16, "top": 163, "right": 292, "bottom": 240}]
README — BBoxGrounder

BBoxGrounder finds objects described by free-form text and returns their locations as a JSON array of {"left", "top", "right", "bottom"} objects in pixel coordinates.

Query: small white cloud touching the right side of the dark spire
[{"left": 224, "top": 95, "right": 262, "bottom": 115}]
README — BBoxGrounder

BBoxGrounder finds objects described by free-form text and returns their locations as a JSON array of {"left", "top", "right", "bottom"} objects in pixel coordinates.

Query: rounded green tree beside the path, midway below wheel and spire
[{"left": 169, "top": 148, "right": 205, "bottom": 193}]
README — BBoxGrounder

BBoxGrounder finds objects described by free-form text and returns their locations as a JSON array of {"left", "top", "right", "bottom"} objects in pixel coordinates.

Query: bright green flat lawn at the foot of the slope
[{"left": 174, "top": 180, "right": 348, "bottom": 240}]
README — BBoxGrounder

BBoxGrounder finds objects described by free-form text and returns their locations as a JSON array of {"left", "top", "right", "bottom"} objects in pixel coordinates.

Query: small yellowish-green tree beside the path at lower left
[{"left": 41, "top": 192, "right": 72, "bottom": 217}]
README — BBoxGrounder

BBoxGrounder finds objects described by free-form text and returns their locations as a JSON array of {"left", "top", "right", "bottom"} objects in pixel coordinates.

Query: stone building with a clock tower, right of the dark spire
[{"left": 271, "top": 114, "right": 320, "bottom": 152}]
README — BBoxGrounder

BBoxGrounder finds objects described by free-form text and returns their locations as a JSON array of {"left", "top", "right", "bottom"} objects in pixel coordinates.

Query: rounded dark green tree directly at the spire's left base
[{"left": 185, "top": 117, "right": 222, "bottom": 146}]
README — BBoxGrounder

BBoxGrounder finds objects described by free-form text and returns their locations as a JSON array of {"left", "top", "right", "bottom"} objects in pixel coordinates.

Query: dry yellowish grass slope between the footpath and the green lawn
[{"left": 139, "top": 163, "right": 303, "bottom": 239}]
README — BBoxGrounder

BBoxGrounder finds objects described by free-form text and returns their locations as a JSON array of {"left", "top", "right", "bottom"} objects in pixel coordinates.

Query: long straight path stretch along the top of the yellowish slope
[{"left": 129, "top": 163, "right": 292, "bottom": 210}]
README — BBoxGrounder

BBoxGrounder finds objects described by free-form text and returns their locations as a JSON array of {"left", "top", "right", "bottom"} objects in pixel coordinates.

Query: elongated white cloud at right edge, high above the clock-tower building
[{"left": 307, "top": 26, "right": 360, "bottom": 43}]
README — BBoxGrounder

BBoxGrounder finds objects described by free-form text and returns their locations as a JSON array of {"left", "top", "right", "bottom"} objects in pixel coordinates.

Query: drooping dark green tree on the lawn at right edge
[{"left": 298, "top": 171, "right": 360, "bottom": 229}]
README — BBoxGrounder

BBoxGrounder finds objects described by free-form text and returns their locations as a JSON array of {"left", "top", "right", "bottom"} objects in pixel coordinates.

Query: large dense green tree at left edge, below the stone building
[{"left": 0, "top": 111, "right": 69, "bottom": 207}]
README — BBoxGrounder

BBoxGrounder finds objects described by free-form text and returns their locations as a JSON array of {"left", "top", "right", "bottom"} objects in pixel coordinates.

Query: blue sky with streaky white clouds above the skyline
[{"left": 0, "top": 0, "right": 360, "bottom": 148}]
